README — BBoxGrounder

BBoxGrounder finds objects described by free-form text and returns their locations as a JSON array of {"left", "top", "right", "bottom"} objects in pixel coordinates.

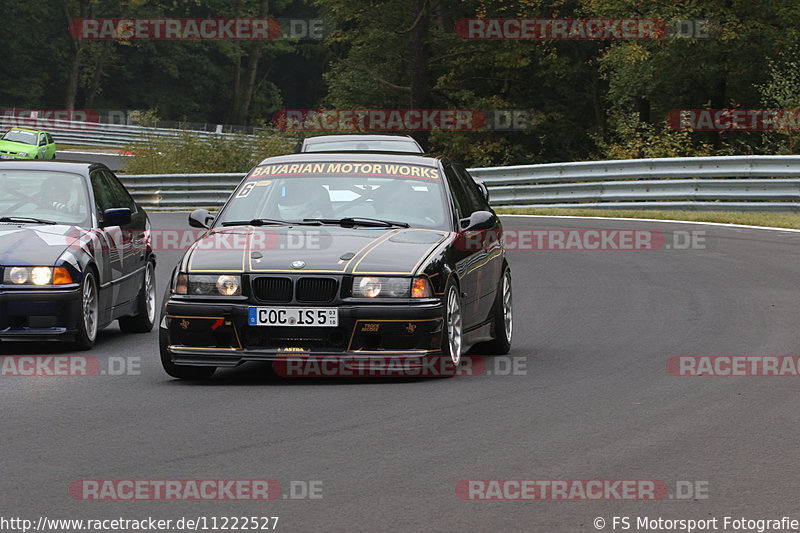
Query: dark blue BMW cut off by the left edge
[{"left": 0, "top": 161, "right": 156, "bottom": 349}]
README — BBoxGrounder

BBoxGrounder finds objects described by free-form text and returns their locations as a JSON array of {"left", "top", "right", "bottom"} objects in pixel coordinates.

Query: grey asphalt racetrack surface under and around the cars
[{"left": 0, "top": 213, "right": 800, "bottom": 532}]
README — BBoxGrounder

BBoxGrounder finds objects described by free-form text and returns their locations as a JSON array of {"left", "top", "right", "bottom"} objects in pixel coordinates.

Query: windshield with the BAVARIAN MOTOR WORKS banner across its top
[{"left": 217, "top": 163, "right": 449, "bottom": 229}]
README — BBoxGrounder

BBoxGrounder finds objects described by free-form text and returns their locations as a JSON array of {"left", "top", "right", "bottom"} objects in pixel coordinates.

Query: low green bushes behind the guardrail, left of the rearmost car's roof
[{"left": 125, "top": 130, "right": 295, "bottom": 174}]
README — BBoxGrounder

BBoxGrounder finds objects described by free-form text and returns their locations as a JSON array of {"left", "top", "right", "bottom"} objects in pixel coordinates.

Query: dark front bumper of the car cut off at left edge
[{"left": 0, "top": 285, "right": 81, "bottom": 340}]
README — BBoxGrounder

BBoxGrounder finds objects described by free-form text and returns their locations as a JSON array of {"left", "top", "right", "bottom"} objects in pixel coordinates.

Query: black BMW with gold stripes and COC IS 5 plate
[{"left": 159, "top": 152, "right": 512, "bottom": 379}]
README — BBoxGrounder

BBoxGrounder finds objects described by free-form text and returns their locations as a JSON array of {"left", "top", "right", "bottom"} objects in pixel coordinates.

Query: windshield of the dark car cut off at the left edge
[{"left": 0, "top": 167, "right": 89, "bottom": 222}]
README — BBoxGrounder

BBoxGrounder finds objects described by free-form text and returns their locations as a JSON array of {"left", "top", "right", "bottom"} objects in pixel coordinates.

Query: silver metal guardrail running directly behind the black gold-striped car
[{"left": 120, "top": 156, "right": 800, "bottom": 212}]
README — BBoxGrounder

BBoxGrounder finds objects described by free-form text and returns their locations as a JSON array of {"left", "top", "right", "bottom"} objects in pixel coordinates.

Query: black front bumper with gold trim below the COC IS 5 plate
[{"left": 159, "top": 298, "right": 443, "bottom": 367}]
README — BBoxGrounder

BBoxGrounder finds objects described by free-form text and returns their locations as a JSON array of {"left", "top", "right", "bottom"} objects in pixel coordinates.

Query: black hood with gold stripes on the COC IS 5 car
[{"left": 182, "top": 226, "right": 450, "bottom": 275}]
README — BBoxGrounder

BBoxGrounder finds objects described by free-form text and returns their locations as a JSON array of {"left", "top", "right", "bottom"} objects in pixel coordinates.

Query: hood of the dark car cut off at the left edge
[{"left": 0, "top": 222, "right": 86, "bottom": 265}]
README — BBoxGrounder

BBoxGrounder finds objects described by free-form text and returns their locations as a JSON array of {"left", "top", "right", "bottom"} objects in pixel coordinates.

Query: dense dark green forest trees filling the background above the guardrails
[{"left": 7, "top": 0, "right": 800, "bottom": 166}]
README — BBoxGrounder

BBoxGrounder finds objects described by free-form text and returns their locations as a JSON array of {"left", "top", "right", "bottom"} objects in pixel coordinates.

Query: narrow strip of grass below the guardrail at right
[{"left": 496, "top": 207, "right": 800, "bottom": 229}]
